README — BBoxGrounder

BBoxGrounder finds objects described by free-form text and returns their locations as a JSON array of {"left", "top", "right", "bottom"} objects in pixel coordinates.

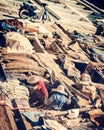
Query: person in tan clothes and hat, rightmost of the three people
[{"left": 76, "top": 72, "right": 101, "bottom": 108}]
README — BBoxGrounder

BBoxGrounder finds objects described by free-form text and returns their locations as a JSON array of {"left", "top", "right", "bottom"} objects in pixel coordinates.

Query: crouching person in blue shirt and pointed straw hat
[{"left": 45, "top": 84, "right": 76, "bottom": 110}]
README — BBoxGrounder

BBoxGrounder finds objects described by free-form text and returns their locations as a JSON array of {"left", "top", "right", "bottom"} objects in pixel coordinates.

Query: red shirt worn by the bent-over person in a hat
[{"left": 35, "top": 80, "right": 48, "bottom": 100}]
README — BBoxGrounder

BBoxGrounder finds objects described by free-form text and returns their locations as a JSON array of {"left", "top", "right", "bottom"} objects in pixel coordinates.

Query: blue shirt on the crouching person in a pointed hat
[{"left": 46, "top": 92, "right": 68, "bottom": 110}]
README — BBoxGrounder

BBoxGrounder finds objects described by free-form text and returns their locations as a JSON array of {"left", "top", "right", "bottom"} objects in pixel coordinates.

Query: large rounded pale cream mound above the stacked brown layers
[{"left": 4, "top": 32, "right": 33, "bottom": 53}]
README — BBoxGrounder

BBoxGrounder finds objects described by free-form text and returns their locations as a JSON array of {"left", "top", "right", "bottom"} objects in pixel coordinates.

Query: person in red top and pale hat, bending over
[{"left": 27, "top": 76, "right": 48, "bottom": 107}]
